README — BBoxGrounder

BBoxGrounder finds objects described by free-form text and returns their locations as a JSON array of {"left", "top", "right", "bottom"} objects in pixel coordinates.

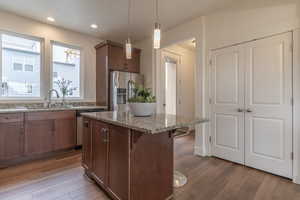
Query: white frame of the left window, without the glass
[{"left": 0, "top": 29, "right": 45, "bottom": 102}]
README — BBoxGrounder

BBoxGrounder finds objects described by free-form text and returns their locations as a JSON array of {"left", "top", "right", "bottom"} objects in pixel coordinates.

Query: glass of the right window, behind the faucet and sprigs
[{"left": 52, "top": 43, "right": 80, "bottom": 98}]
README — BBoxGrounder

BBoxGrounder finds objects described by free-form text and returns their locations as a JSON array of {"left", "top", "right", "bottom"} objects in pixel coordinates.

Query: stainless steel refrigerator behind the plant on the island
[{"left": 110, "top": 71, "right": 144, "bottom": 111}]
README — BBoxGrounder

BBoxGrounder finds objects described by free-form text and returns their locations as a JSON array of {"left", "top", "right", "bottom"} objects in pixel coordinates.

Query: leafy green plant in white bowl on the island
[{"left": 128, "top": 83, "right": 156, "bottom": 117}]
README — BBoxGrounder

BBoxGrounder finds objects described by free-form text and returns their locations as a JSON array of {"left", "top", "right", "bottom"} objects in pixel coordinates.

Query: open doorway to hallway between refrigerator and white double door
[{"left": 156, "top": 38, "right": 196, "bottom": 117}]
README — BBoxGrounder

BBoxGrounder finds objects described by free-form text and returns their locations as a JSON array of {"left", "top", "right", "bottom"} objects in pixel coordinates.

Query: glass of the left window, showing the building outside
[{"left": 0, "top": 33, "right": 41, "bottom": 98}]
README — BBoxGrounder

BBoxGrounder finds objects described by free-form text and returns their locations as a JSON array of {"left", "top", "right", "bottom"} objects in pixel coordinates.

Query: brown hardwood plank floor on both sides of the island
[{"left": 0, "top": 136, "right": 300, "bottom": 200}]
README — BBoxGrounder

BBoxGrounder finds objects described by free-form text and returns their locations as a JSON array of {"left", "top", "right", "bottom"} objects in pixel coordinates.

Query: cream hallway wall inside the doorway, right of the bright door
[{"left": 166, "top": 45, "right": 196, "bottom": 117}]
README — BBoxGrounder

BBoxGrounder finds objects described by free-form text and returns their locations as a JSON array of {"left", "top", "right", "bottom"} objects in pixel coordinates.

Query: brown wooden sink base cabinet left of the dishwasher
[{"left": 25, "top": 111, "right": 76, "bottom": 156}]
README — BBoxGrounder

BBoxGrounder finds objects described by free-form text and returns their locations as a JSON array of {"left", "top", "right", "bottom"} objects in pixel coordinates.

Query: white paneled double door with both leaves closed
[{"left": 210, "top": 33, "right": 292, "bottom": 178}]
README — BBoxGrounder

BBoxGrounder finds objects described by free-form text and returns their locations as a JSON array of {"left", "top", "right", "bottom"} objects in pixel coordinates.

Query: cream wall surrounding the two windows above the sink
[{"left": 0, "top": 11, "right": 101, "bottom": 101}]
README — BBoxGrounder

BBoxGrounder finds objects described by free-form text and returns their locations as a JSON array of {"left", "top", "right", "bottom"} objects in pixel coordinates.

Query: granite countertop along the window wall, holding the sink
[{"left": 0, "top": 106, "right": 107, "bottom": 114}]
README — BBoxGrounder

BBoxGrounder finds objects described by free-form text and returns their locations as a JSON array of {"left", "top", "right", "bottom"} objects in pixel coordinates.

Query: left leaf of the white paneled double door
[{"left": 210, "top": 46, "right": 244, "bottom": 164}]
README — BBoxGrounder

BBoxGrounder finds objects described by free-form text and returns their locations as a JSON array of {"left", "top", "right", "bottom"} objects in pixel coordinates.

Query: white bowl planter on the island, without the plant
[{"left": 129, "top": 103, "right": 156, "bottom": 117}]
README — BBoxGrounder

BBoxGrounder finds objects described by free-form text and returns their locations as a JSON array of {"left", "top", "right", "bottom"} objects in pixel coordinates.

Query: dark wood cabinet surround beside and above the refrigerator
[{"left": 95, "top": 41, "right": 141, "bottom": 107}]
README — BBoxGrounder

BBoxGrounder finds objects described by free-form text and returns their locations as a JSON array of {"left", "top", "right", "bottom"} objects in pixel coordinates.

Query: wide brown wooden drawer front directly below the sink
[{"left": 25, "top": 111, "right": 76, "bottom": 121}]
